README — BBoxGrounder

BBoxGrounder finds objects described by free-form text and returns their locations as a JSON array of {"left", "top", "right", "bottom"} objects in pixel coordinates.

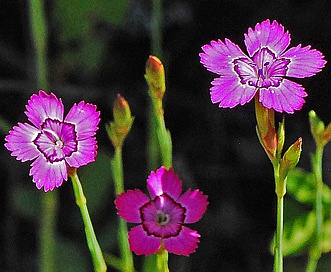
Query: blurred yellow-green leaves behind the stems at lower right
[{"left": 271, "top": 168, "right": 331, "bottom": 256}]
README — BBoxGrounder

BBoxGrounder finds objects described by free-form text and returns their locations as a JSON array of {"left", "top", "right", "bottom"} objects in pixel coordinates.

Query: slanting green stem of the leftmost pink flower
[{"left": 70, "top": 169, "right": 107, "bottom": 272}]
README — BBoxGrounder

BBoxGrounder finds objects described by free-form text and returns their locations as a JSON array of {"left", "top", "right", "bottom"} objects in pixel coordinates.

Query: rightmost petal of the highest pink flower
[{"left": 282, "top": 44, "right": 326, "bottom": 78}]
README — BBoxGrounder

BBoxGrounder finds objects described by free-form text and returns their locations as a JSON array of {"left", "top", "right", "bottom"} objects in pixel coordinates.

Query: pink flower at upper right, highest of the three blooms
[{"left": 200, "top": 19, "right": 326, "bottom": 113}]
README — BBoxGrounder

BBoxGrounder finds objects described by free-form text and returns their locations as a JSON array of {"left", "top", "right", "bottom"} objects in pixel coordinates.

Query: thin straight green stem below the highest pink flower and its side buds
[{"left": 273, "top": 162, "right": 286, "bottom": 272}]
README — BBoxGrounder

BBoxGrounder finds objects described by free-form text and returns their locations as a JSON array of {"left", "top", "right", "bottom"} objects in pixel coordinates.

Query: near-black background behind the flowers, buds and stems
[{"left": 0, "top": 0, "right": 331, "bottom": 272}]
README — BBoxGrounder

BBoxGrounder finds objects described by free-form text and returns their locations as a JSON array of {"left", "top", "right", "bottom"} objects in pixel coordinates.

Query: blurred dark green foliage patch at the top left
[{"left": 52, "top": 0, "right": 129, "bottom": 75}]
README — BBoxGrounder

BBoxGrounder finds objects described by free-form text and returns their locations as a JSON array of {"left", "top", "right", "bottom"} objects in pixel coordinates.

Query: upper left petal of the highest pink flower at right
[{"left": 199, "top": 39, "right": 247, "bottom": 75}]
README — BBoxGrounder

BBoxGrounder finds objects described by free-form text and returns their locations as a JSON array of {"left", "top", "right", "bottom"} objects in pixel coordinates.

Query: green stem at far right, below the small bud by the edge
[{"left": 306, "top": 145, "right": 324, "bottom": 272}]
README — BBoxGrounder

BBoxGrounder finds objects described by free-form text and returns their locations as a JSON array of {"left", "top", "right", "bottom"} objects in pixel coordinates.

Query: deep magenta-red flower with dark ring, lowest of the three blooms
[{"left": 115, "top": 166, "right": 208, "bottom": 256}]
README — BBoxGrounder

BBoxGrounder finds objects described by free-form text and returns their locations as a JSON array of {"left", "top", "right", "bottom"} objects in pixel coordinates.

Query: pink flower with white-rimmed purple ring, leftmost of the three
[{"left": 5, "top": 90, "right": 100, "bottom": 192}]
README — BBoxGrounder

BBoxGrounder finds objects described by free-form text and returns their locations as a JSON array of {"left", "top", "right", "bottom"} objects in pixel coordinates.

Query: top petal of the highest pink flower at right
[{"left": 244, "top": 19, "right": 291, "bottom": 56}]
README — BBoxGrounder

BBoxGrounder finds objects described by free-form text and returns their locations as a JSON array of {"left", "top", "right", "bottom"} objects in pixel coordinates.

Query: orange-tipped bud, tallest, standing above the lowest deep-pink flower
[{"left": 145, "top": 56, "right": 166, "bottom": 99}]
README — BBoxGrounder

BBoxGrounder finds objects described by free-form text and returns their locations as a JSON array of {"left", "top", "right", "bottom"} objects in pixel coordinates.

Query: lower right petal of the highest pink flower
[{"left": 259, "top": 79, "right": 307, "bottom": 113}]
